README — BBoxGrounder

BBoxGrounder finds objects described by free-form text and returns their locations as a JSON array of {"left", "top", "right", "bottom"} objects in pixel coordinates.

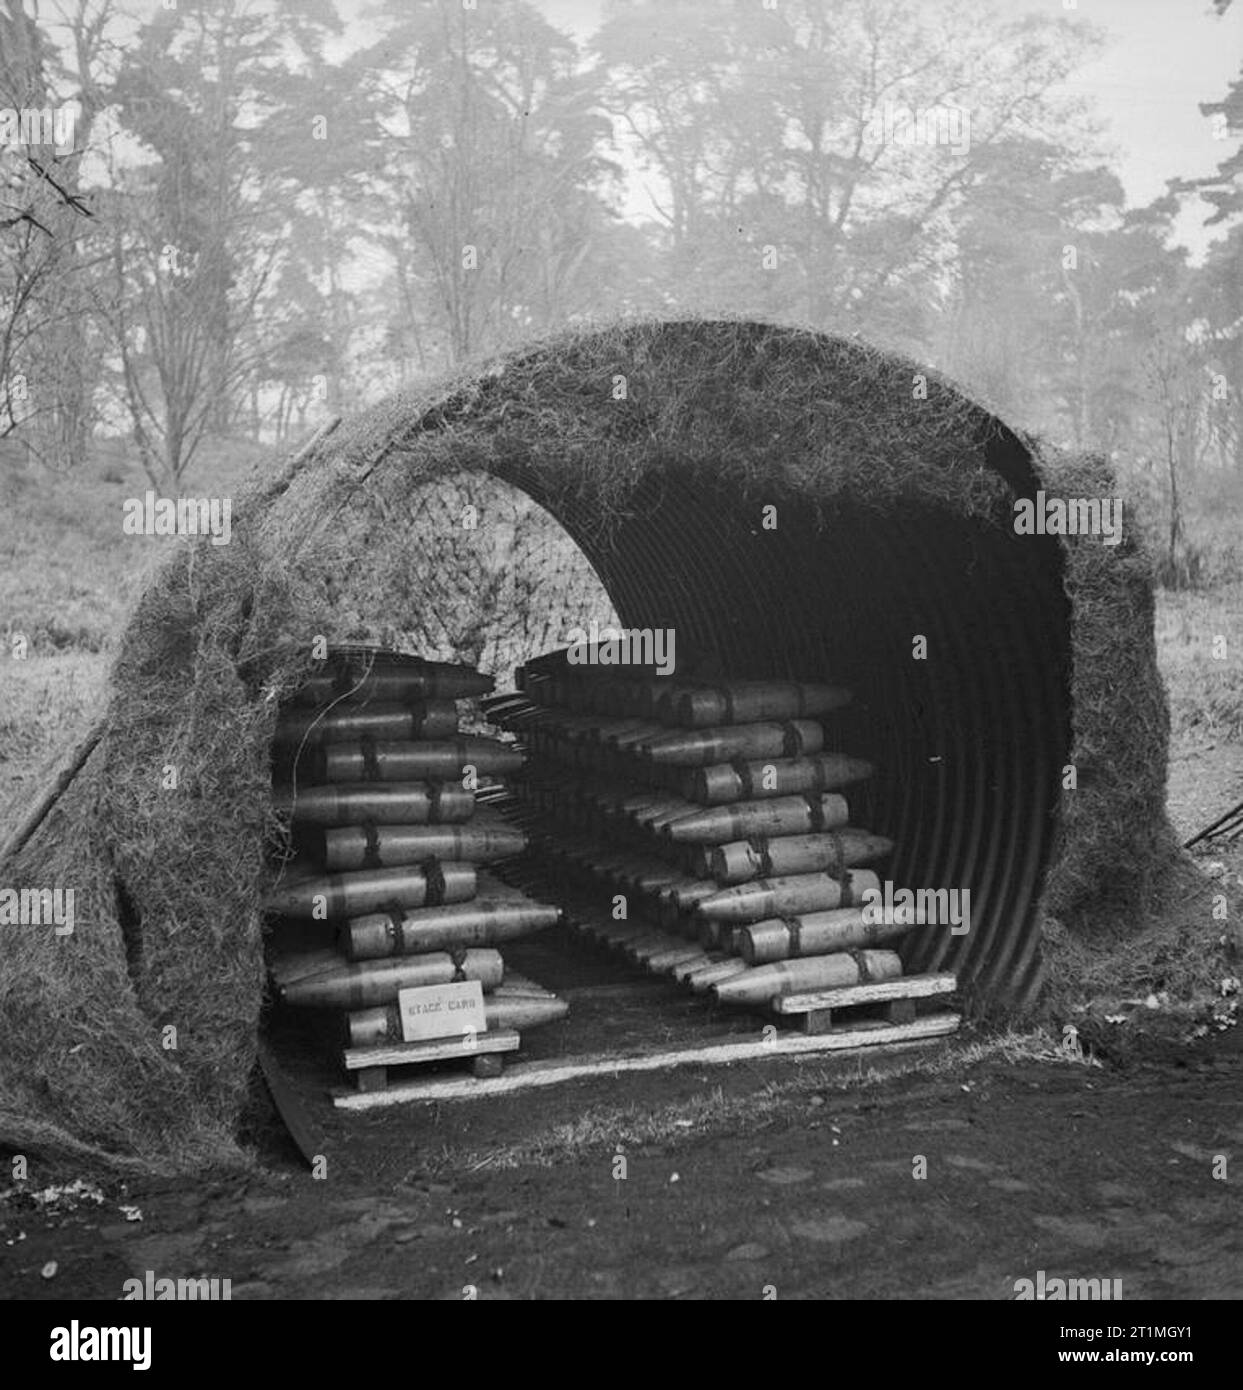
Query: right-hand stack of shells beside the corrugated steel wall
[{"left": 489, "top": 648, "right": 918, "bottom": 1006}]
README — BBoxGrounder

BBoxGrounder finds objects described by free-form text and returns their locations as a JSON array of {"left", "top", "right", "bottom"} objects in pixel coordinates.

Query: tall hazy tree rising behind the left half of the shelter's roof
[{"left": 348, "top": 0, "right": 615, "bottom": 363}]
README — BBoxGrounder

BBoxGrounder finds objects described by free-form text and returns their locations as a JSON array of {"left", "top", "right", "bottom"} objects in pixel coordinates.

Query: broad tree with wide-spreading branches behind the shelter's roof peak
[{"left": 596, "top": 0, "right": 1091, "bottom": 348}]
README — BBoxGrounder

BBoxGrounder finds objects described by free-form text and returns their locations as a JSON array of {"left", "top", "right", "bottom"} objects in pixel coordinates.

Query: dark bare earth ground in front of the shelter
[{"left": 0, "top": 639, "right": 1243, "bottom": 1300}]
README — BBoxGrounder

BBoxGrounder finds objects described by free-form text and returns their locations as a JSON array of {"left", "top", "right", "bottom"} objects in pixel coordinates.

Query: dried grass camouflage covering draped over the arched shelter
[{"left": 0, "top": 322, "right": 1195, "bottom": 1170}]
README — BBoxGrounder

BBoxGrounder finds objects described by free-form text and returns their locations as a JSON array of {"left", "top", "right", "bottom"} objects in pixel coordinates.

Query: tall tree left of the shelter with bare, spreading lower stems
[{"left": 100, "top": 0, "right": 340, "bottom": 482}]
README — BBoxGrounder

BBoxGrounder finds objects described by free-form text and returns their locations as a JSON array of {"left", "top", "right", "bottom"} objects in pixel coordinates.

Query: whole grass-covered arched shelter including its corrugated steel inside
[{"left": 0, "top": 321, "right": 1190, "bottom": 1169}]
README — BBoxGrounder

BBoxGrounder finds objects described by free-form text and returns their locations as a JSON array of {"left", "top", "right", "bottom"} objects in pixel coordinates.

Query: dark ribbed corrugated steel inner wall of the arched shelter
[{"left": 481, "top": 405, "right": 1072, "bottom": 1015}]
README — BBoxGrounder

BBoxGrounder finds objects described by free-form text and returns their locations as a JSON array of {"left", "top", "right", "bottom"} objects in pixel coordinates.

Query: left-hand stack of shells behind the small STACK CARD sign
[{"left": 264, "top": 648, "right": 569, "bottom": 1047}]
